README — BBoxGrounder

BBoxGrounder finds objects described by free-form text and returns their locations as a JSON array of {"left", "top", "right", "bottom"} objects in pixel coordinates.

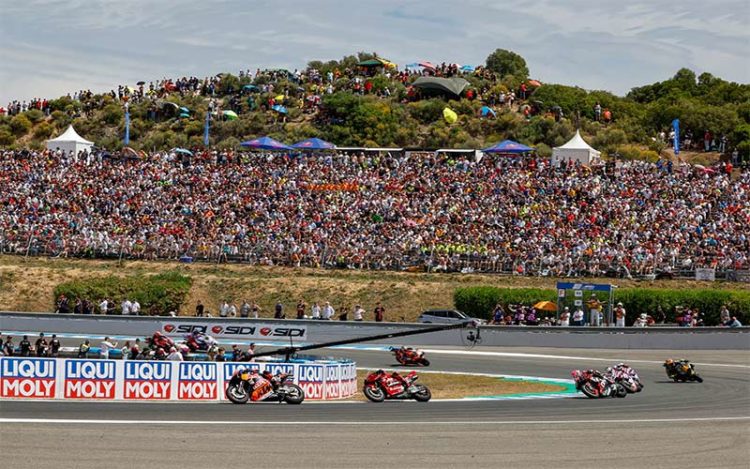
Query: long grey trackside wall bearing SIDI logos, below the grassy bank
[{"left": 0, "top": 312, "right": 750, "bottom": 350}]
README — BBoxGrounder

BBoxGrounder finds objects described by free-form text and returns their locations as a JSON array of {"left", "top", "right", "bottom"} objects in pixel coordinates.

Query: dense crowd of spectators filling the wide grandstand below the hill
[{"left": 0, "top": 146, "right": 750, "bottom": 276}]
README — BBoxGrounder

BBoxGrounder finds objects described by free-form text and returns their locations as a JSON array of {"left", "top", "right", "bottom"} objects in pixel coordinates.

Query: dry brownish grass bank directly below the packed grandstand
[{"left": 0, "top": 256, "right": 750, "bottom": 321}]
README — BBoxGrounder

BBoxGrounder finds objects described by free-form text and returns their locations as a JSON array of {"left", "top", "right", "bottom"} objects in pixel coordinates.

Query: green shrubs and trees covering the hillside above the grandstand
[{"left": 0, "top": 50, "right": 750, "bottom": 159}]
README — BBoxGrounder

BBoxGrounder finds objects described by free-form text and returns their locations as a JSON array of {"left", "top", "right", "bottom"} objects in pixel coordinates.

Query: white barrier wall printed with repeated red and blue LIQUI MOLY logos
[{"left": 0, "top": 357, "right": 357, "bottom": 401}]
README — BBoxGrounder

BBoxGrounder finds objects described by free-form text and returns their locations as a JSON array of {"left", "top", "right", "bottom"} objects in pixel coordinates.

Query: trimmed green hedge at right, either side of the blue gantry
[{"left": 453, "top": 286, "right": 750, "bottom": 325}]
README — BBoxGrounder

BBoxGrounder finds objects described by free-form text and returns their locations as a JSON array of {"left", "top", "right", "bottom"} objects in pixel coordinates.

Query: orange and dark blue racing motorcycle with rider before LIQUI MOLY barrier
[{"left": 226, "top": 369, "right": 305, "bottom": 404}]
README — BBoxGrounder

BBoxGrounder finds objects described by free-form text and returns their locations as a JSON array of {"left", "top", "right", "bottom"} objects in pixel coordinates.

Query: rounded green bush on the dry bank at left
[{"left": 55, "top": 272, "right": 192, "bottom": 315}]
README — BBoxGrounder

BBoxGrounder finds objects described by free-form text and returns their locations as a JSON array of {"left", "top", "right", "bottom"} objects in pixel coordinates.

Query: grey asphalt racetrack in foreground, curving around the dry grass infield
[{"left": 0, "top": 348, "right": 750, "bottom": 469}]
